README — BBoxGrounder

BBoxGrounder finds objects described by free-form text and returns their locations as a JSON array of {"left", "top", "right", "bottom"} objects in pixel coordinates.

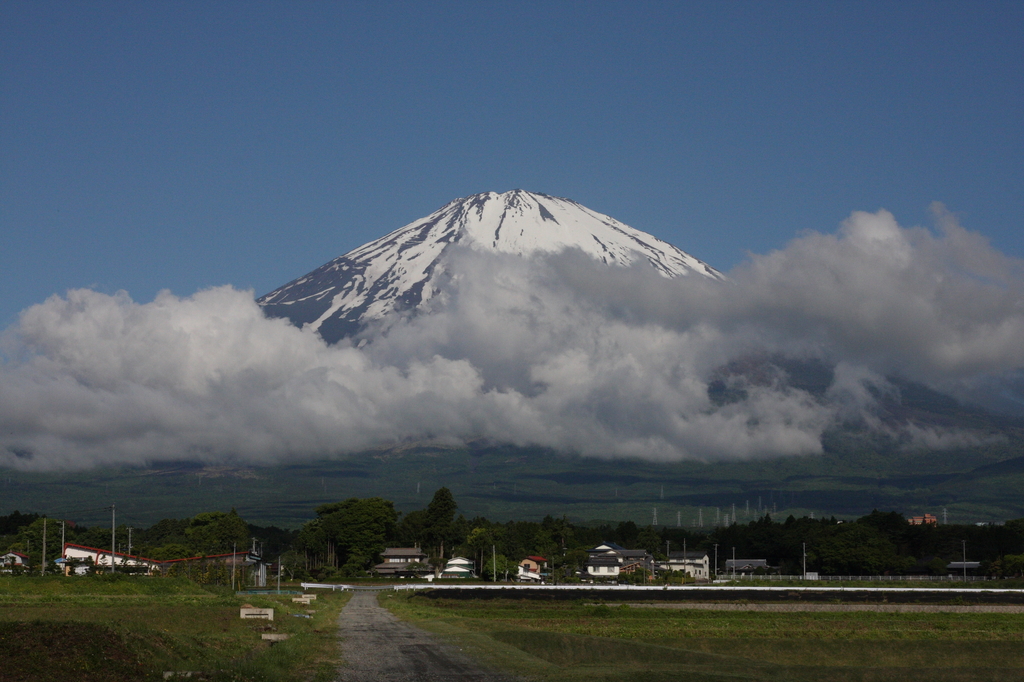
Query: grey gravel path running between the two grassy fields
[{"left": 337, "top": 591, "right": 509, "bottom": 682}]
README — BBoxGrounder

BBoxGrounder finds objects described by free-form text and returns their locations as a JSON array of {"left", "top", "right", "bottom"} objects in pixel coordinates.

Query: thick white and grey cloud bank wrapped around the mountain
[{"left": 0, "top": 208, "right": 1024, "bottom": 470}]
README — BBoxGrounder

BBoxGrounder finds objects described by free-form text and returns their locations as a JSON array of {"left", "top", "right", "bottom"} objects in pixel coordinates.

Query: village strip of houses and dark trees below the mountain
[{"left": 0, "top": 488, "right": 1024, "bottom": 587}]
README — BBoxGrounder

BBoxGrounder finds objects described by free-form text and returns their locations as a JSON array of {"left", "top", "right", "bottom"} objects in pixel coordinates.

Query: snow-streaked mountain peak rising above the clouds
[{"left": 257, "top": 189, "right": 724, "bottom": 343}]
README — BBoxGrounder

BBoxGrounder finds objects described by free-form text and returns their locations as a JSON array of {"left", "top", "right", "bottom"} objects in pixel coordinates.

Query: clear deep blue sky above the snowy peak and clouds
[{"left": 0, "top": 0, "right": 1024, "bottom": 328}]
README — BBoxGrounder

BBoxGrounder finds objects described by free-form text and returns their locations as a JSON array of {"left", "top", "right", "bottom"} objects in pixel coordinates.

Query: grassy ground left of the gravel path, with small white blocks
[{"left": 0, "top": 577, "right": 348, "bottom": 682}]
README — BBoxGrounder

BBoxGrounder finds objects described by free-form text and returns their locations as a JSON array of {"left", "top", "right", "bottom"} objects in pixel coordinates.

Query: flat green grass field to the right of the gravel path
[{"left": 381, "top": 594, "right": 1024, "bottom": 682}]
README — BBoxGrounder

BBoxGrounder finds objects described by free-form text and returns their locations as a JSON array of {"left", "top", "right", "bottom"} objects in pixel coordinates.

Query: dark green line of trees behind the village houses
[{"left": 6, "top": 487, "right": 1024, "bottom": 580}]
